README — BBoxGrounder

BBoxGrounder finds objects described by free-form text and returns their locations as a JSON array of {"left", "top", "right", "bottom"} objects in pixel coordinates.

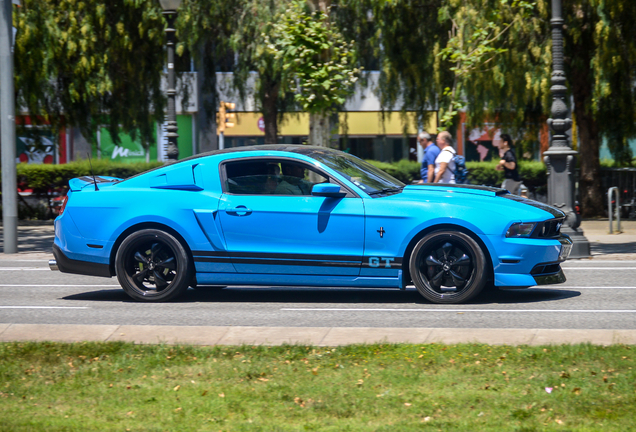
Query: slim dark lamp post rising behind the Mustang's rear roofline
[{"left": 159, "top": 0, "right": 181, "bottom": 163}]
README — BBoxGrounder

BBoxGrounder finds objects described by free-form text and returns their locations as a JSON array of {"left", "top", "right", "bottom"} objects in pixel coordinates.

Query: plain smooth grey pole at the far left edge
[{"left": 0, "top": 0, "right": 18, "bottom": 254}]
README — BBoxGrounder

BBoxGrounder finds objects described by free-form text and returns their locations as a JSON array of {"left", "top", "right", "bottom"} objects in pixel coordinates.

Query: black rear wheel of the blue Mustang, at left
[{"left": 115, "top": 229, "right": 192, "bottom": 302}]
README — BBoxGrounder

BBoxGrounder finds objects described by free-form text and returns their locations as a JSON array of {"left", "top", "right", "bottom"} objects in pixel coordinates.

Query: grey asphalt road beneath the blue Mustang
[{"left": 0, "top": 254, "right": 636, "bottom": 330}]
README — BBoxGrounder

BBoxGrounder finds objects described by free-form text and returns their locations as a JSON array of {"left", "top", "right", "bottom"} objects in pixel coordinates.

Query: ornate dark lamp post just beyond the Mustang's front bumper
[{"left": 543, "top": 0, "right": 590, "bottom": 258}]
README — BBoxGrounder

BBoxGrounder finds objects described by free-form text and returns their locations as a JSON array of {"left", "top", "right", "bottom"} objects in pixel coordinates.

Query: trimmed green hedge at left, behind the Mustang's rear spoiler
[{"left": 17, "top": 159, "right": 162, "bottom": 194}]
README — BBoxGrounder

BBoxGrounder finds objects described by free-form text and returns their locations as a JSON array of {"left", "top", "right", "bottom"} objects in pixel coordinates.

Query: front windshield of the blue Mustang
[{"left": 311, "top": 152, "right": 404, "bottom": 197}]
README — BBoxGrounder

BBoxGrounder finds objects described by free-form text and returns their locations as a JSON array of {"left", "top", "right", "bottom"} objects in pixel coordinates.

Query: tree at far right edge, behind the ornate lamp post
[{"left": 564, "top": 0, "right": 636, "bottom": 216}]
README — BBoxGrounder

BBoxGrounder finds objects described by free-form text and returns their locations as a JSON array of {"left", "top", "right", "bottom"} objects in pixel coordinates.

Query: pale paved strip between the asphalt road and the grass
[{"left": 0, "top": 324, "right": 636, "bottom": 346}]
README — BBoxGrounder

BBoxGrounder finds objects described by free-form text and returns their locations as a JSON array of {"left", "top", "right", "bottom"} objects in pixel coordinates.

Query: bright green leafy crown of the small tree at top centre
[{"left": 263, "top": 1, "right": 360, "bottom": 113}]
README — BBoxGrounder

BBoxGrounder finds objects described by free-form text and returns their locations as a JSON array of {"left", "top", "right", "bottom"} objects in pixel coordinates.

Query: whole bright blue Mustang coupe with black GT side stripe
[{"left": 50, "top": 145, "right": 572, "bottom": 303}]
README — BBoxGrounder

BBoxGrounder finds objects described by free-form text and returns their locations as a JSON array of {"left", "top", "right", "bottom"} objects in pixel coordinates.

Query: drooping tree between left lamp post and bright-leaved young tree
[{"left": 178, "top": 0, "right": 293, "bottom": 144}]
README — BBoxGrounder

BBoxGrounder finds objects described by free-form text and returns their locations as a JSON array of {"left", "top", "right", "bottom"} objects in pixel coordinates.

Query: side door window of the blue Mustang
[{"left": 225, "top": 159, "right": 329, "bottom": 195}]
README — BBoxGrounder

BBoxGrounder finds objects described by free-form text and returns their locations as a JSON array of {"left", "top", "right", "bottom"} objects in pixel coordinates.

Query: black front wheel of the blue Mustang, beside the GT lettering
[{"left": 409, "top": 231, "right": 486, "bottom": 304}]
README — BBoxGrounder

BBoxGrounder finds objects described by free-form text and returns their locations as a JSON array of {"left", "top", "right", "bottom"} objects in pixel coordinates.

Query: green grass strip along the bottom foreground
[{"left": 0, "top": 343, "right": 636, "bottom": 432}]
